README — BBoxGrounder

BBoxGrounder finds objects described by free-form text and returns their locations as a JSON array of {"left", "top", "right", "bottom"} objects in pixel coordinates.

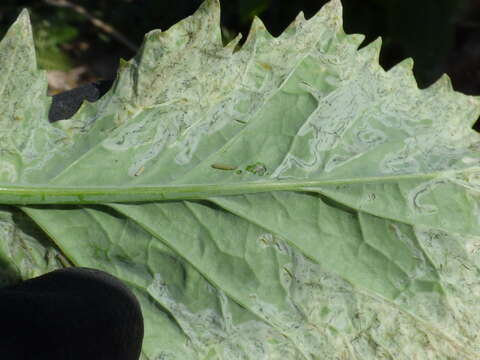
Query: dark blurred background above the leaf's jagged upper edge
[{"left": 0, "top": 0, "right": 480, "bottom": 126}]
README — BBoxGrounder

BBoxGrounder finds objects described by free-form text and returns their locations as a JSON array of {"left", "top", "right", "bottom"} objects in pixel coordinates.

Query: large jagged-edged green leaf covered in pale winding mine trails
[{"left": 0, "top": 0, "right": 480, "bottom": 360}]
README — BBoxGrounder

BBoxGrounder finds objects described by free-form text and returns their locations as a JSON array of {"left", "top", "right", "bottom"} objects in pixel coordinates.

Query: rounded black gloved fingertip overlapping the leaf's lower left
[{"left": 0, "top": 267, "right": 143, "bottom": 360}]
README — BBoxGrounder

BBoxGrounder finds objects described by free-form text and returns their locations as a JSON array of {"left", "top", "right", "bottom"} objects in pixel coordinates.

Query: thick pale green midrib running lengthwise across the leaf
[{"left": 0, "top": 167, "right": 468, "bottom": 205}]
